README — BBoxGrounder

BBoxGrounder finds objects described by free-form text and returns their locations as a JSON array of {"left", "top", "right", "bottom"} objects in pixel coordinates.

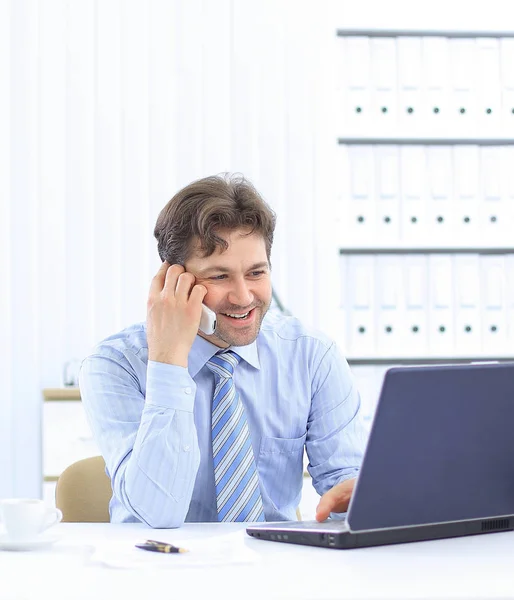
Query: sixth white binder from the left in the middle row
[{"left": 480, "top": 146, "right": 502, "bottom": 246}]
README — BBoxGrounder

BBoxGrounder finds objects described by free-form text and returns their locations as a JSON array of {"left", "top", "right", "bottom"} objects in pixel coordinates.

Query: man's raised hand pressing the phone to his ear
[{"left": 147, "top": 262, "right": 207, "bottom": 368}]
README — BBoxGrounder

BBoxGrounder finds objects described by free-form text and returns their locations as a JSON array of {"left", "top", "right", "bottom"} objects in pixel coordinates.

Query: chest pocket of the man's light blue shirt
[{"left": 257, "top": 434, "right": 307, "bottom": 490}]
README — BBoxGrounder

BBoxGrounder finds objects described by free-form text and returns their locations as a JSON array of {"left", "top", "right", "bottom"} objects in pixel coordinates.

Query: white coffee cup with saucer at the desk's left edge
[{"left": 0, "top": 498, "right": 62, "bottom": 542}]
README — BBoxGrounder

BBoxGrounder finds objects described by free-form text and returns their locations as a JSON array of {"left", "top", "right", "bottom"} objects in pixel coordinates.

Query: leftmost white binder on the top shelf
[{"left": 339, "top": 36, "right": 373, "bottom": 136}]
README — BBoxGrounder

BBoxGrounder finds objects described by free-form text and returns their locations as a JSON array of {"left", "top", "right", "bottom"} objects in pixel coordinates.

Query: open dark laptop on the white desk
[{"left": 246, "top": 363, "right": 514, "bottom": 548}]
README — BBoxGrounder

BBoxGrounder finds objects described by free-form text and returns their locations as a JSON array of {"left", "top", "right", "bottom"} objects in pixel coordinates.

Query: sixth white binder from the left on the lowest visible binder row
[{"left": 480, "top": 254, "right": 508, "bottom": 356}]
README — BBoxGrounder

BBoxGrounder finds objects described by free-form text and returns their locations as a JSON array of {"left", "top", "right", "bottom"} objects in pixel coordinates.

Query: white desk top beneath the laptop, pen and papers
[{"left": 0, "top": 524, "right": 514, "bottom": 600}]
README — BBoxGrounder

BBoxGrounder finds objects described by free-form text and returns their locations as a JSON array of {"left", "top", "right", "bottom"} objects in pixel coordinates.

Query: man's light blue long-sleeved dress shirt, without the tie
[{"left": 80, "top": 312, "right": 367, "bottom": 527}]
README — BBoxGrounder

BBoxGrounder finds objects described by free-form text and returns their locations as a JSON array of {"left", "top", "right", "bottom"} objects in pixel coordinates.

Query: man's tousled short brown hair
[{"left": 154, "top": 173, "right": 275, "bottom": 265}]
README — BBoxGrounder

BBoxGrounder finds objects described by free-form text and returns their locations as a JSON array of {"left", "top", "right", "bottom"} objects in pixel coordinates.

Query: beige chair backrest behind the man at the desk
[{"left": 55, "top": 456, "right": 112, "bottom": 523}]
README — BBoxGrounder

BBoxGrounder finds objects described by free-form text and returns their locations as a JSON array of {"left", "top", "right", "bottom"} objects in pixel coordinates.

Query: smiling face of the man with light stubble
[{"left": 184, "top": 229, "right": 271, "bottom": 348}]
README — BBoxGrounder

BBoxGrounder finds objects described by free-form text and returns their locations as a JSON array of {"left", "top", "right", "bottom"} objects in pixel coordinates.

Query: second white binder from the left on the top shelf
[{"left": 371, "top": 37, "right": 398, "bottom": 135}]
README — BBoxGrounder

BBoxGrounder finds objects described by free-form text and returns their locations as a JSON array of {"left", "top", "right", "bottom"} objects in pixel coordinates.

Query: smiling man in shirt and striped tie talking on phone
[{"left": 80, "top": 176, "right": 366, "bottom": 527}]
